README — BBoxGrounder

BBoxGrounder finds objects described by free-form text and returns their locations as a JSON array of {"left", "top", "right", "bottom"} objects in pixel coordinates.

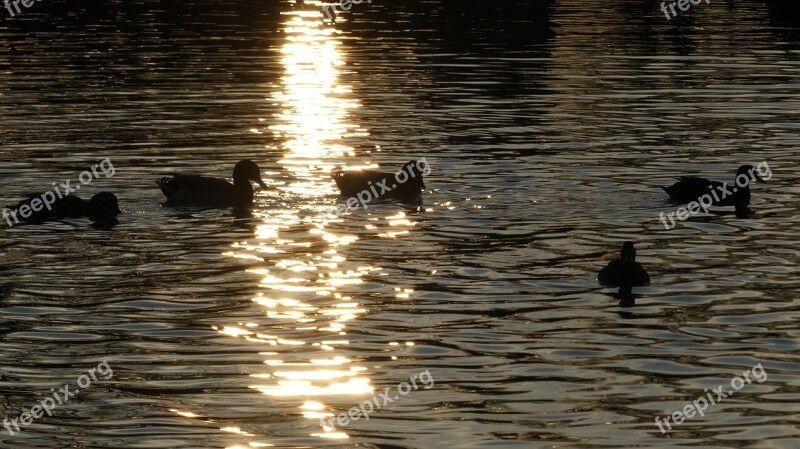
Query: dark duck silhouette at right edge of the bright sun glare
[{"left": 332, "top": 159, "right": 427, "bottom": 202}]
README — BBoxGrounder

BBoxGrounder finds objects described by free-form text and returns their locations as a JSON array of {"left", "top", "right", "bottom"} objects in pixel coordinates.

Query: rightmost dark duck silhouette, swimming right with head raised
[{"left": 661, "top": 165, "right": 766, "bottom": 212}]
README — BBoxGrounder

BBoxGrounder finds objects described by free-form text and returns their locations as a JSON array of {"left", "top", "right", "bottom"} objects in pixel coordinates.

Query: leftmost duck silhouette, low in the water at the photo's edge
[{"left": 3, "top": 192, "right": 122, "bottom": 223}]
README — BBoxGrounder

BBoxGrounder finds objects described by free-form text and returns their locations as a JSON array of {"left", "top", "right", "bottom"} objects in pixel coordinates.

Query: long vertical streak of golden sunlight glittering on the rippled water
[{"left": 217, "top": 5, "right": 378, "bottom": 449}]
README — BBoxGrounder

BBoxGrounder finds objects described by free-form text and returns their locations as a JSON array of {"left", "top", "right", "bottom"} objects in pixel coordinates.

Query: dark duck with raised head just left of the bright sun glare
[{"left": 157, "top": 159, "right": 267, "bottom": 207}]
